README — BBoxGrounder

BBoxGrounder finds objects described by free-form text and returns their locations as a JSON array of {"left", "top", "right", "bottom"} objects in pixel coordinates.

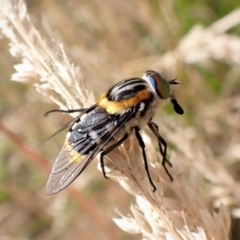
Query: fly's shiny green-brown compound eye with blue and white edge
[{"left": 143, "top": 70, "right": 171, "bottom": 99}]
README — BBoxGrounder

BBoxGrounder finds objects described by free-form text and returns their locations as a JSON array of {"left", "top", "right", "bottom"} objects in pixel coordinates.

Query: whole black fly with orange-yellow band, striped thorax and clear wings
[{"left": 46, "top": 70, "right": 183, "bottom": 194}]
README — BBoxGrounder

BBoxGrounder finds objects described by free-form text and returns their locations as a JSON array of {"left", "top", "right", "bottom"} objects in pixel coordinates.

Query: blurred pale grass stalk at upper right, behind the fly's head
[{"left": 124, "top": 8, "right": 240, "bottom": 74}]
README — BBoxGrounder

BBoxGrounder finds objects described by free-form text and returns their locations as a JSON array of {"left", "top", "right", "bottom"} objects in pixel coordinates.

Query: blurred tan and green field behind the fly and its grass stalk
[{"left": 0, "top": 0, "right": 240, "bottom": 239}]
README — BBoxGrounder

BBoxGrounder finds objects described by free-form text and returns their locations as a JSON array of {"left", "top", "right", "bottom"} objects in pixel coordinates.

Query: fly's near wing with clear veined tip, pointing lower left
[{"left": 46, "top": 109, "right": 135, "bottom": 194}]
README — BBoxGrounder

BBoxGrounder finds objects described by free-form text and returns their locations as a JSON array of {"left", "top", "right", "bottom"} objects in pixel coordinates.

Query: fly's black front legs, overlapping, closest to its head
[{"left": 148, "top": 122, "right": 173, "bottom": 181}]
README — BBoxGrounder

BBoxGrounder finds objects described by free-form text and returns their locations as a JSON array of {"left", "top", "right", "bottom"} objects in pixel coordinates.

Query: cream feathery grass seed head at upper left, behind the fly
[{"left": 1, "top": 0, "right": 94, "bottom": 109}]
